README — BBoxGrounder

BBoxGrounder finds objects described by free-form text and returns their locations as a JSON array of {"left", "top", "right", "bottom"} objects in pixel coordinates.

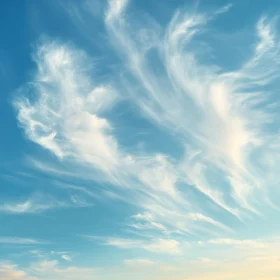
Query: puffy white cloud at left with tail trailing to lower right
[{"left": 15, "top": 38, "right": 229, "bottom": 236}]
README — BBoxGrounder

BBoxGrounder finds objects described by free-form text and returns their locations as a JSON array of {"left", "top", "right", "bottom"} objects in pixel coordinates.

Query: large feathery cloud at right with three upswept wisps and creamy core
[{"left": 104, "top": 0, "right": 279, "bottom": 219}]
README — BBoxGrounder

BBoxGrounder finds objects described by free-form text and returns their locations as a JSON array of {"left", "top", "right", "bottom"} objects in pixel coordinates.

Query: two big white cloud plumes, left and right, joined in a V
[{"left": 15, "top": 1, "right": 278, "bottom": 230}]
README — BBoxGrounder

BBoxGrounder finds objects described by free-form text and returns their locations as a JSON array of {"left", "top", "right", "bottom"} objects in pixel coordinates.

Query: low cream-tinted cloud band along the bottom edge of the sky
[{"left": 0, "top": 237, "right": 280, "bottom": 280}]
